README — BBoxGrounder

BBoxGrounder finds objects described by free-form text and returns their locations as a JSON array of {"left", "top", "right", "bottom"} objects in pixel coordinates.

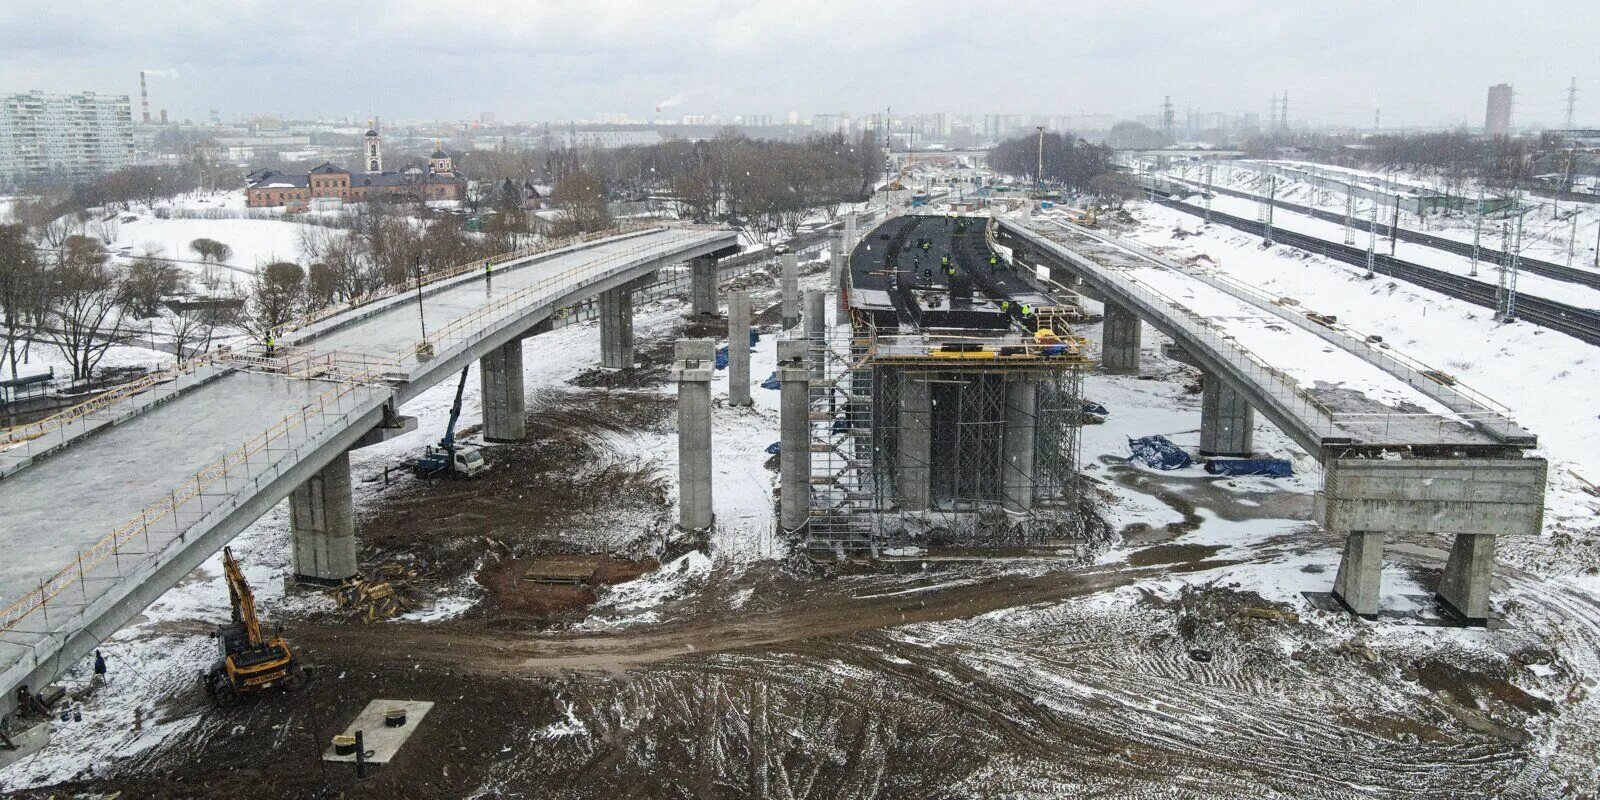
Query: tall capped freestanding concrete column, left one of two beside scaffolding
[{"left": 672, "top": 339, "right": 717, "bottom": 531}]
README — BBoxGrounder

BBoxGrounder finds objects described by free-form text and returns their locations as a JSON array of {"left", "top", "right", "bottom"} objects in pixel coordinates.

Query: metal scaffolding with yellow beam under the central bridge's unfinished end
[{"left": 805, "top": 320, "right": 1091, "bottom": 557}]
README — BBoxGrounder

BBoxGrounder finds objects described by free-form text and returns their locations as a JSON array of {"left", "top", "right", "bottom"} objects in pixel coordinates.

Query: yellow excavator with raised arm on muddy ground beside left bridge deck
[{"left": 200, "top": 547, "right": 309, "bottom": 709}]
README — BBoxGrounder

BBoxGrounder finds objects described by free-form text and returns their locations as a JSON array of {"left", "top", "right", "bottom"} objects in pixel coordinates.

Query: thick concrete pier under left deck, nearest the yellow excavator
[{"left": 290, "top": 453, "right": 355, "bottom": 584}]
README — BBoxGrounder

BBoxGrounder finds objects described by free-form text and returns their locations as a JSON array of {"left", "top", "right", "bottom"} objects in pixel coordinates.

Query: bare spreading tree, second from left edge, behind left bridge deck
[{"left": 43, "top": 237, "right": 125, "bottom": 381}]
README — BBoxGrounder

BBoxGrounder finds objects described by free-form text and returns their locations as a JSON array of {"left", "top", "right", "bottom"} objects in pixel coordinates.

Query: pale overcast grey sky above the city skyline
[{"left": 0, "top": 0, "right": 1600, "bottom": 126}]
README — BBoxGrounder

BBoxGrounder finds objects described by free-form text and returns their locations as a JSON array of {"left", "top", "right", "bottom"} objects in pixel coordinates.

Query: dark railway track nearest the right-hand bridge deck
[{"left": 1162, "top": 198, "right": 1600, "bottom": 346}]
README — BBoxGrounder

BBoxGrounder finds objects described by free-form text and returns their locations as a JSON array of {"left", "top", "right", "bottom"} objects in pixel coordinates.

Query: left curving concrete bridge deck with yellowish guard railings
[{"left": 0, "top": 229, "right": 736, "bottom": 712}]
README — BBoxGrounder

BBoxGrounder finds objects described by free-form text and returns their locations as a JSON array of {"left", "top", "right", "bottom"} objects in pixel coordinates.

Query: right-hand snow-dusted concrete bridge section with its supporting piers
[{"left": 1000, "top": 219, "right": 1549, "bottom": 624}]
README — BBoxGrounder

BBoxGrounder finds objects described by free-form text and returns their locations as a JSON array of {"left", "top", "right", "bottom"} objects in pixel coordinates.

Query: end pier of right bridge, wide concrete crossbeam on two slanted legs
[{"left": 1317, "top": 458, "right": 1549, "bottom": 622}]
